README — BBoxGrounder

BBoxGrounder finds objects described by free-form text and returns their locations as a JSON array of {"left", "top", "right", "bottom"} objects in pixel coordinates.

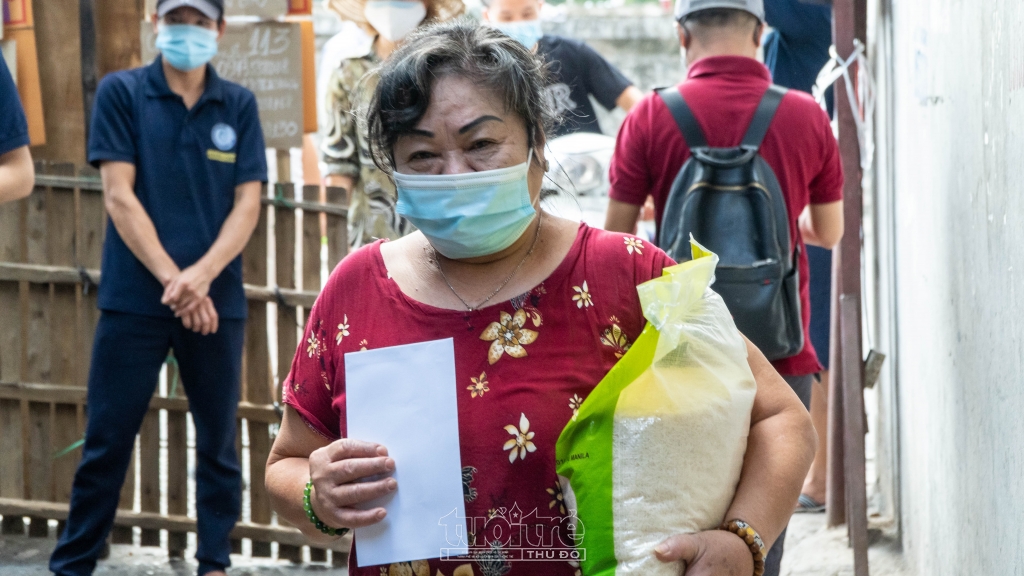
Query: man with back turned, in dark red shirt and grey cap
[{"left": 606, "top": 0, "right": 843, "bottom": 576}]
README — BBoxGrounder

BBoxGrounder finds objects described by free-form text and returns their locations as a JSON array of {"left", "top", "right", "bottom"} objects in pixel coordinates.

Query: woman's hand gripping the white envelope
[{"left": 309, "top": 438, "right": 398, "bottom": 528}]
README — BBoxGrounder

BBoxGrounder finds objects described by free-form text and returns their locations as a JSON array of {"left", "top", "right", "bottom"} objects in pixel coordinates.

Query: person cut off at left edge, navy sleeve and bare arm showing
[{"left": 0, "top": 52, "right": 36, "bottom": 204}]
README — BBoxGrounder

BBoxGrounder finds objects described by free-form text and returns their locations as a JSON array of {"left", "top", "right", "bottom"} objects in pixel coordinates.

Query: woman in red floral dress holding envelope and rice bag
[{"left": 266, "top": 24, "right": 815, "bottom": 576}]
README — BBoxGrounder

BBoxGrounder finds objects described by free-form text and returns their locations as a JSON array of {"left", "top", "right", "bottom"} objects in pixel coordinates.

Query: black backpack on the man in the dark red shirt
[{"left": 657, "top": 85, "right": 804, "bottom": 360}]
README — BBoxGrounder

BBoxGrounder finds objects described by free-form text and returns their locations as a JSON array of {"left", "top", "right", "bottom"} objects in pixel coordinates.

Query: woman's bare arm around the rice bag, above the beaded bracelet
[{"left": 725, "top": 407, "right": 816, "bottom": 547}]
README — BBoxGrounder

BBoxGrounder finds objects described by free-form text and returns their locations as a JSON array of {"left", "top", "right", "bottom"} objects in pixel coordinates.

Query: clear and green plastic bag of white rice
[{"left": 555, "top": 240, "right": 757, "bottom": 576}]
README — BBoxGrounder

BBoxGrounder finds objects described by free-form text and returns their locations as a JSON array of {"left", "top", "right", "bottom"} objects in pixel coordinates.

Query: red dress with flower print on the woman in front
[{"left": 285, "top": 224, "right": 672, "bottom": 576}]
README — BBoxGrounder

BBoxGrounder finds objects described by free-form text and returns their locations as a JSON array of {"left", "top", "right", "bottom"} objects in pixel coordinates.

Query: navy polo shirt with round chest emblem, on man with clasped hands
[{"left": 89, "top": 57, "right": 266, "bottom": 319}]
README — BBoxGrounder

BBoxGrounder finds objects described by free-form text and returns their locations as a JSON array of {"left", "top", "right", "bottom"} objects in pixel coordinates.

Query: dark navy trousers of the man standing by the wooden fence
[{"left": 50, "top": 312, "right": 245, "bottom": 576}]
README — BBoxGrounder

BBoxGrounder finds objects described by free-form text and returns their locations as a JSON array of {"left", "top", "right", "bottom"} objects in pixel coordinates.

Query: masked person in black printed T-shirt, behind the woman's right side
[{"left": 483, "top": 0, "right": 643, "bottom": 137}]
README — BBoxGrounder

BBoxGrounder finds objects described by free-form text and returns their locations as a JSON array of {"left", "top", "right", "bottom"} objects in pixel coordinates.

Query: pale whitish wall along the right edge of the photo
[{"left": 889, "top": 0, "right": 1024, "bottom": 575}]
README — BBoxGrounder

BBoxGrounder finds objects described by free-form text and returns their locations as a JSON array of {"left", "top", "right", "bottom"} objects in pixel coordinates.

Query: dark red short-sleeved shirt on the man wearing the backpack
[{"left": 609, "top": 56, "right": 843, "bottom": 376}]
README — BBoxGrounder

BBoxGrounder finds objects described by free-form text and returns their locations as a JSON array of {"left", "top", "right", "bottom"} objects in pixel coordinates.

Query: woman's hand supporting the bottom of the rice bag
[{"left": 654, "top": 530, "right": 754, "bottom": 576}]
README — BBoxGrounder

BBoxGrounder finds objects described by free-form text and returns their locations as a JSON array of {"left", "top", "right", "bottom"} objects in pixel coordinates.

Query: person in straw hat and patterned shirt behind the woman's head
[{"left": 319, "top": 0, "right": 465, "bottom": 248}]
